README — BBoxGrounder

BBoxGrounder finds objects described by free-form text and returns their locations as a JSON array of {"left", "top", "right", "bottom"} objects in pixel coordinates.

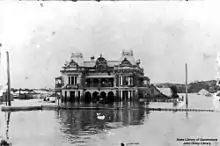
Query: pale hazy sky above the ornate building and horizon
[{"left": 0, "top": 2, "right": 220, "bottom": 88}]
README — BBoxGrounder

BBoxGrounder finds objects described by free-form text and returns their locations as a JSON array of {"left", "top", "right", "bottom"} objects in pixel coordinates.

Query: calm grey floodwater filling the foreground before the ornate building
[{"left": 0, "top": 94, "right": 220, "bottom": 146}]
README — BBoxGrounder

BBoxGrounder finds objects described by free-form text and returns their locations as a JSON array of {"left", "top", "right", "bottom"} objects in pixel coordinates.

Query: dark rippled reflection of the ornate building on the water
[{"left": 56, "top": 102, "right": 149, "bottom": 143}]
